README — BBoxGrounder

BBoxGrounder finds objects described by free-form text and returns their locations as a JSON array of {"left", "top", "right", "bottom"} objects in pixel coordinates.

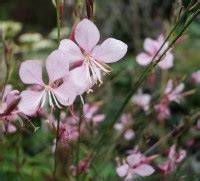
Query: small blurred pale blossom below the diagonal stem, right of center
[{"left": 132, "top": 90, "right": 151, "bottom": 111}]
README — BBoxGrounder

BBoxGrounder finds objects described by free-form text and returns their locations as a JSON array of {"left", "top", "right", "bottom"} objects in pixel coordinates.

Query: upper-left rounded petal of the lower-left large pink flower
[{"left": 19, "top": 60, "right": 44, "bottom": 85}]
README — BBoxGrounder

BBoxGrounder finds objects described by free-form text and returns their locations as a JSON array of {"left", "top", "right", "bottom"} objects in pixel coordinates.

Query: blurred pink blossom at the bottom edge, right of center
[{"left": 116, "top": 153, "right": 155, "bottom": 181}]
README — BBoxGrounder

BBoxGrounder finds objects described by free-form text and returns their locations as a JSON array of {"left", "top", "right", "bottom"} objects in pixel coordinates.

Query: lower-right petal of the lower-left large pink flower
[{"left": 53, "top": 81, "right": 77, "bottom": 106}]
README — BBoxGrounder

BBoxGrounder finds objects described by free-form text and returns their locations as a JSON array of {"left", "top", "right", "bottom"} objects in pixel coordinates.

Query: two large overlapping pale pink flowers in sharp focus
[{"left": 18, "top": 19, "right": 127, "bottom": 115}]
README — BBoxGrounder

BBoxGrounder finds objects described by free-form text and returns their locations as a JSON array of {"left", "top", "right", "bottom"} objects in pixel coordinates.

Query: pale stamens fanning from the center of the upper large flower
[{"left": 84, "top": 54, "right": 112, "bottom": 85}]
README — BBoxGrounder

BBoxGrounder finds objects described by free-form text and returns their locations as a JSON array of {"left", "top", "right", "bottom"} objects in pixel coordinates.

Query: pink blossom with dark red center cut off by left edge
[{"left": 0, "top": 85, "right": 19, "bottom": 133}]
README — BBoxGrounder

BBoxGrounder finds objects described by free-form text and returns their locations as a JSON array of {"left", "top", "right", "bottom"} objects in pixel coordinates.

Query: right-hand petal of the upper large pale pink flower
[{"left": 92, "top": 38, "right": 128, "bottom": 63}]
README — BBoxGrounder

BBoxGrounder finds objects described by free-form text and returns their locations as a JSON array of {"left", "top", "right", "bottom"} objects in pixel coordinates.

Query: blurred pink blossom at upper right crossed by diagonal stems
[{"left": 136, "top": 35, "right": 174, "bottom": 69}]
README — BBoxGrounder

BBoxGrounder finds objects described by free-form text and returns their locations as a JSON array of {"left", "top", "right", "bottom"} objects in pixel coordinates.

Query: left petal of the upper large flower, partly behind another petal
[{"left": 58, "top": 39, "right": 84, "bottom": 63}]
